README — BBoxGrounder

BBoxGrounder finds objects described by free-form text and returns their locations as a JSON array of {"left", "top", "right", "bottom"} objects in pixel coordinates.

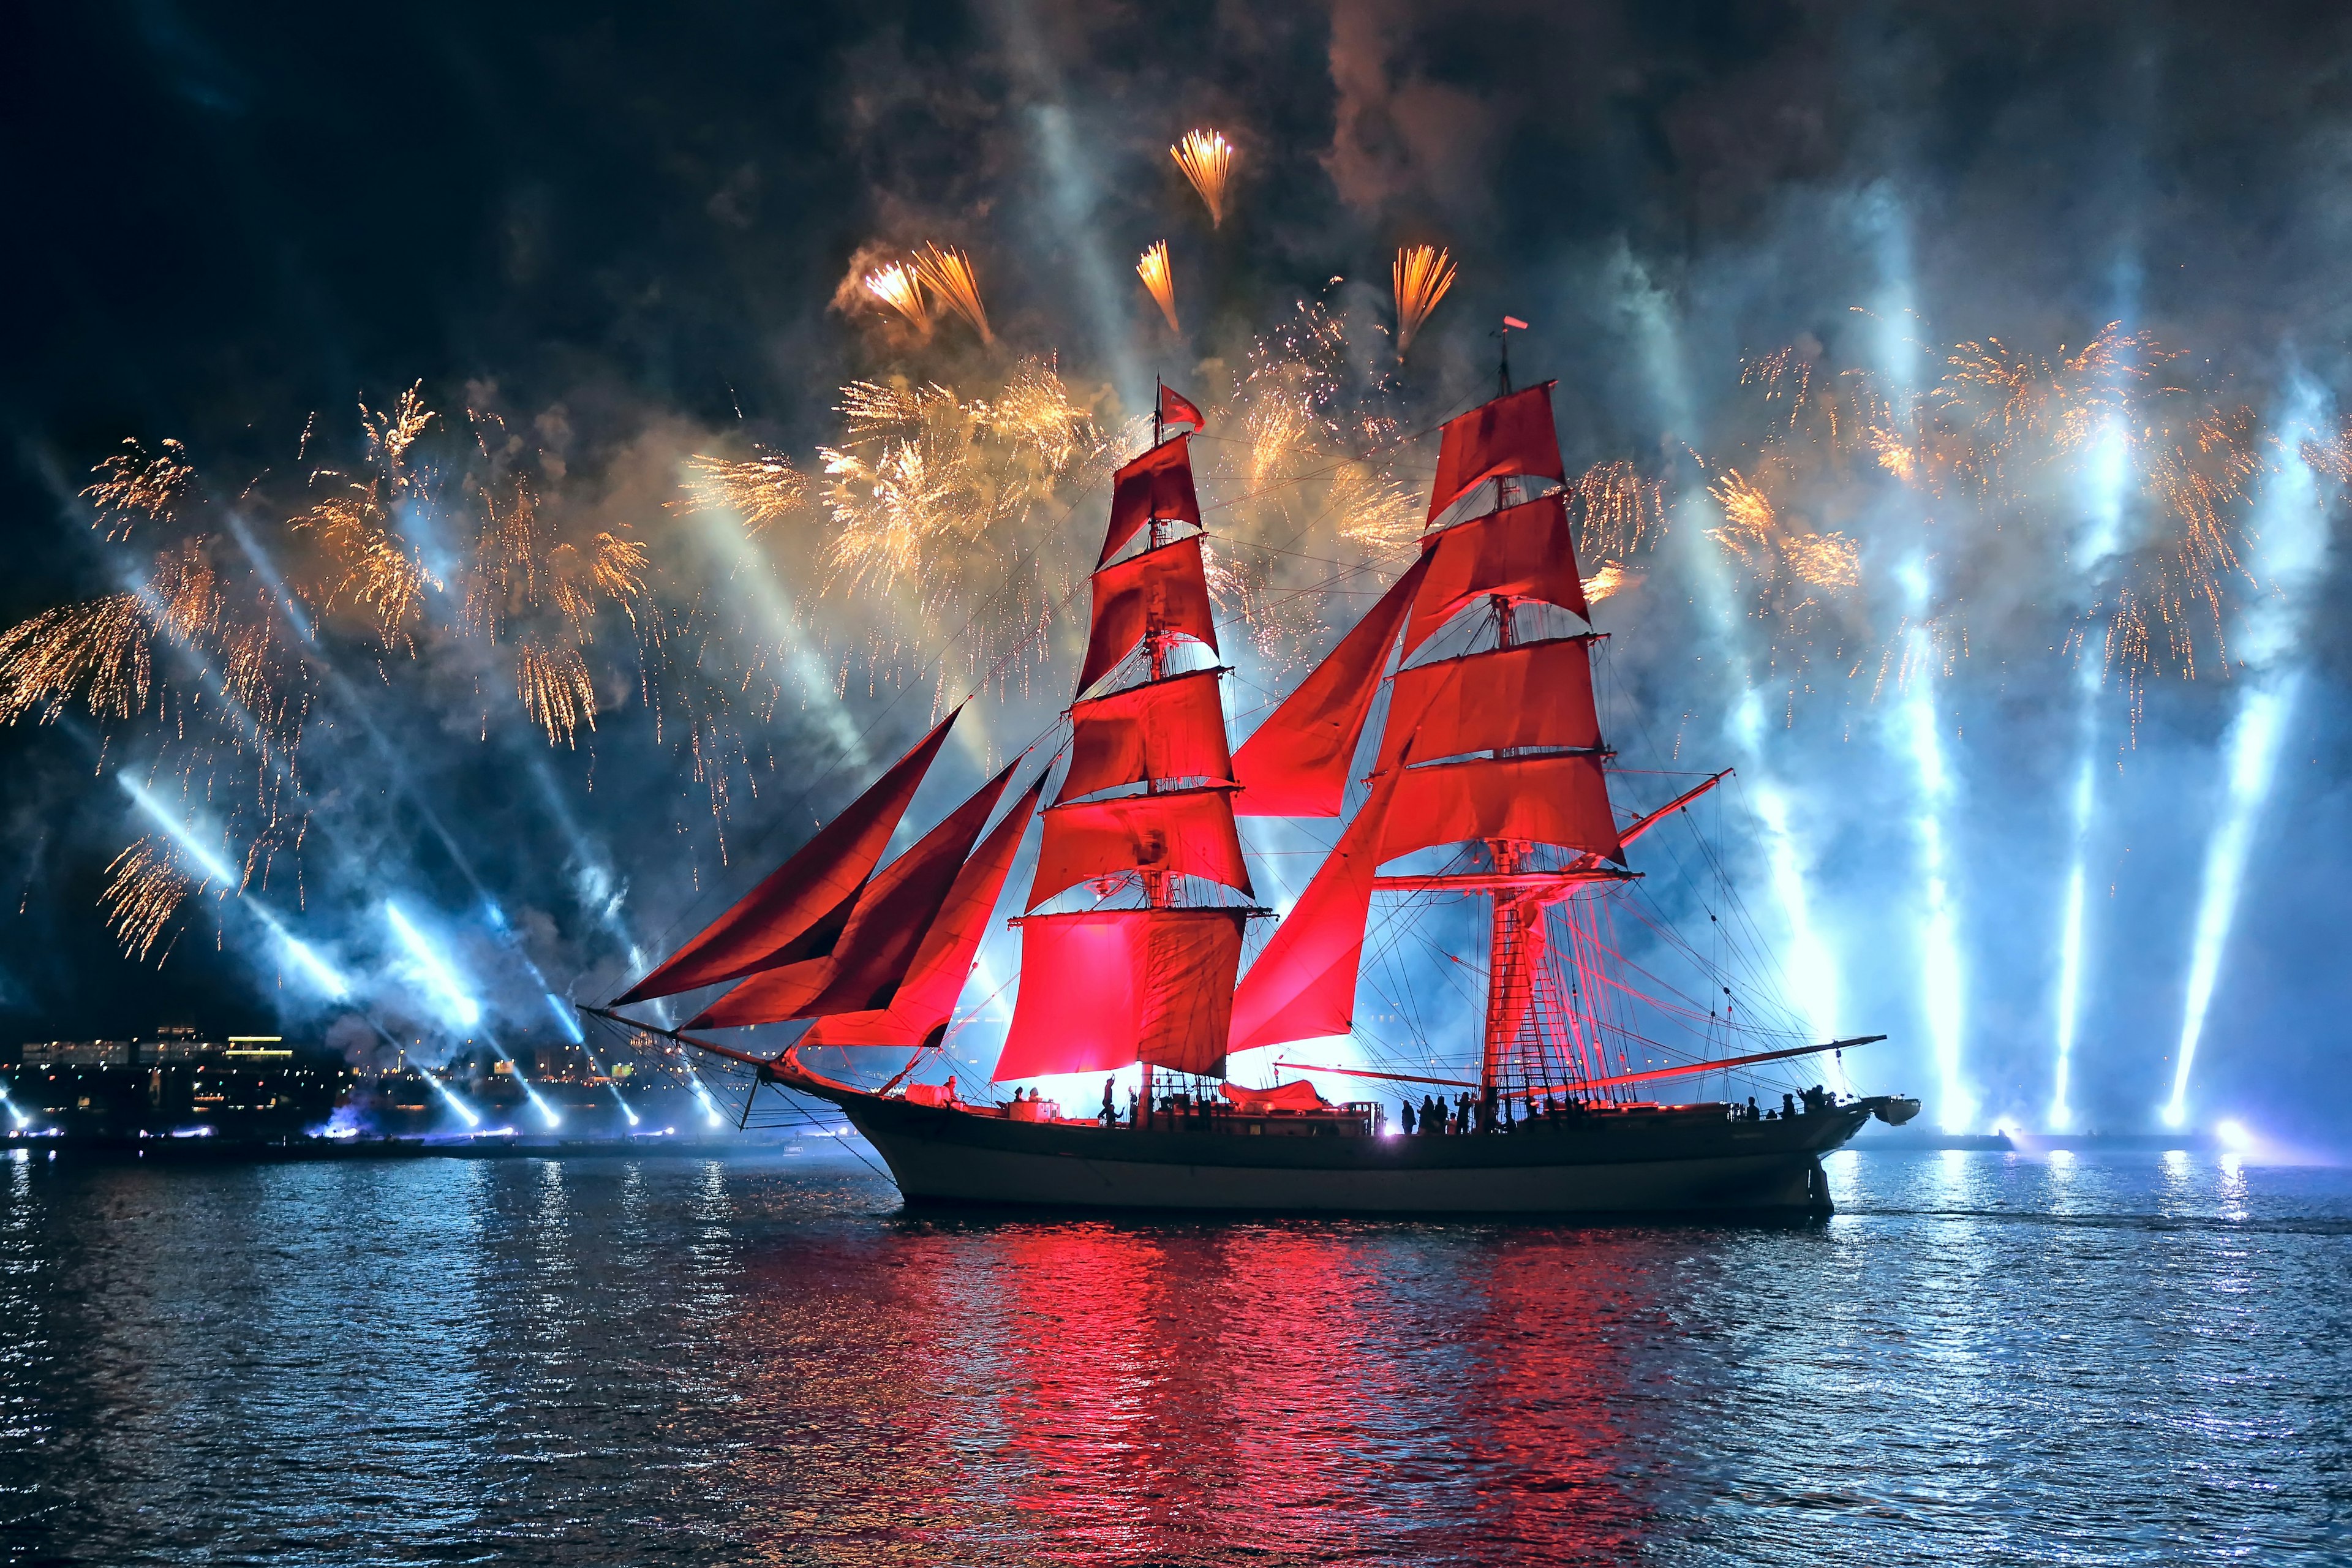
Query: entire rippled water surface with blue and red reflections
[{"left": 0, "top": 1152, "right": 2352, "bottom": 1563}]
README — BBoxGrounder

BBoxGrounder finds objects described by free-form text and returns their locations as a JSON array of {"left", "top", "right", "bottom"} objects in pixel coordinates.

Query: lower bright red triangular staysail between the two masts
[{"left": 1226, "top": 752, "right": 1402, "bottom": 1051}]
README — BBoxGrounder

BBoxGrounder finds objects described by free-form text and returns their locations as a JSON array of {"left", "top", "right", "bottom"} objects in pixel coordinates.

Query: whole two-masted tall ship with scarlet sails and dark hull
[{"left": 590, "top": 383, "right": 1919, "bottom": 1213}]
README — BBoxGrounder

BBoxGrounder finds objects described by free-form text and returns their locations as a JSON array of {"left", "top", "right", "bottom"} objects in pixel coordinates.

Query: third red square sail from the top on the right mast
[{"left": 1374, "top": 637, "right": 1602, "bottom": 771}]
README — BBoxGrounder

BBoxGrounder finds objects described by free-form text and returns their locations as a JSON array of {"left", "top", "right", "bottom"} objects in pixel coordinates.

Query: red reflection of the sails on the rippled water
[{"left": 739, "top": 1223, "right": 1670, "bottom": 1563}]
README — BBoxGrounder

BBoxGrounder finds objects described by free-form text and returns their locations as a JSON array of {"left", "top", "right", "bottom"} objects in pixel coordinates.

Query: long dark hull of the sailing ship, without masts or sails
[{"left": 826, "top": 1093, "right": 1872, "bottom": 1215}]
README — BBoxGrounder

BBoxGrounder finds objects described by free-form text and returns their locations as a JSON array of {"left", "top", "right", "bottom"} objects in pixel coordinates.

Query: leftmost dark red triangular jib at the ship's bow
[{"left": 619, "top": 707, "right": 962, "bottom": 1004}]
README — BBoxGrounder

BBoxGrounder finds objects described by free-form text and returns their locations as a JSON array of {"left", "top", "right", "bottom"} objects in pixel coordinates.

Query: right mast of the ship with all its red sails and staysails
[{"left": 1232, "top": 383, "right": 1630, "bottom": 1086}]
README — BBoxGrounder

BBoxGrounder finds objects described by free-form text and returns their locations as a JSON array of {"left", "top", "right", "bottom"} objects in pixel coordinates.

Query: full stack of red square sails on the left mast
[{"left": 995, "top": 414, "right": 1251, "bottom": 1084}]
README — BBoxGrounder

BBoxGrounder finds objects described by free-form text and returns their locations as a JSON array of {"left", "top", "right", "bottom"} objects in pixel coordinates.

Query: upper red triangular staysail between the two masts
[{"left": 1232, "top": 555, "right": 1430, "bottom": 816}]
